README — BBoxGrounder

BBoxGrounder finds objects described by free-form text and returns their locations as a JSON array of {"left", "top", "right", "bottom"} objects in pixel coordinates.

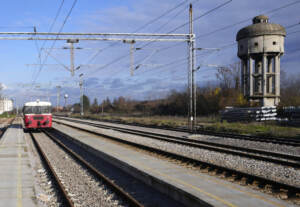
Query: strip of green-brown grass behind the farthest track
[{"left": 72, "top": 114, "right": 300, "bottom": 139}]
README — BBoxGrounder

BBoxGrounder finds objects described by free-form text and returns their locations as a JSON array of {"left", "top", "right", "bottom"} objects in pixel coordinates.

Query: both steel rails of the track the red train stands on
[{"left": 30, "top": 130, "right": 143, "bottom": 207}]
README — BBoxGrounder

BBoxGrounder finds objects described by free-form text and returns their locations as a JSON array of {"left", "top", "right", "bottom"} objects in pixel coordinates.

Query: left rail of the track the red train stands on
[{"left": 30, "top": 132, "right": 74, "bottom": 207}]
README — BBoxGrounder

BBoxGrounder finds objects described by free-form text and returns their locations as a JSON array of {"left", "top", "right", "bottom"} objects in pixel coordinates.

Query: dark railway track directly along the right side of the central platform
[{"left": 50, "top": 125, "right": 300, "bottom": 194}]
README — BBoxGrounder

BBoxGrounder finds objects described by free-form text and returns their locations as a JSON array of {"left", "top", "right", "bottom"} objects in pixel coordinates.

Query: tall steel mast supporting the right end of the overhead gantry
[{"left": 188, "top": 4, "right": 195, "bottom": 132}]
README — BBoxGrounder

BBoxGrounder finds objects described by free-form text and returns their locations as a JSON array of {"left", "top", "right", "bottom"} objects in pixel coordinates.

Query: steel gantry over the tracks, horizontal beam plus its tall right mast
[{"left": 0, "top": 5, "right": 196, "bottom": 131}]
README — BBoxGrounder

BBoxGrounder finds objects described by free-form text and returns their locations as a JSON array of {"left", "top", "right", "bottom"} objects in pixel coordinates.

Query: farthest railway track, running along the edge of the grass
[{"left": 55, "top": 116, "right": 300, "bottom": 147}]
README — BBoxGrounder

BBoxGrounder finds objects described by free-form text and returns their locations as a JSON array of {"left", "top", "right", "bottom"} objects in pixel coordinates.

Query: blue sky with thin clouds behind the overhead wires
[{"left": 0, "top": 0, "right": 300, "bottom": 105}]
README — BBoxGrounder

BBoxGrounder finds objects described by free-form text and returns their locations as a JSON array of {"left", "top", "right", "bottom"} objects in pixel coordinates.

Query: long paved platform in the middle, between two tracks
[{"left": 53, "top": 122, "right": 295, "bottom": 207}]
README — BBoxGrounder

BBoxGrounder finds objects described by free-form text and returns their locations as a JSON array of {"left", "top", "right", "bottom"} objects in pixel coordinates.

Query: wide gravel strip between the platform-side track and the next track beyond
[{"left": 54, "top": 123, "right": 300, "bottom": 187}]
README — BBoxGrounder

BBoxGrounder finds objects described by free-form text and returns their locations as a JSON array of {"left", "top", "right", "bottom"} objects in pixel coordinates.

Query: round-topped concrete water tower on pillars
[{"left": 236, "top": 15, "right": 286, "bottom": 106}]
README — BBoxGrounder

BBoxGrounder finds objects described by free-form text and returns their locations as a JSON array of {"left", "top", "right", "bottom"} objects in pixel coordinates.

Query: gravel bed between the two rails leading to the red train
[{"left": 36, "top": 134, "right": 127, "bottom": 207}]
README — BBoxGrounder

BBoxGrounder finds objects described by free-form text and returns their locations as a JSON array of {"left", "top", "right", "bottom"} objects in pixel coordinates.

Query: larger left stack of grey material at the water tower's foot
[{"left": 221, "top": 106, "right": 277, "bottom": 122}]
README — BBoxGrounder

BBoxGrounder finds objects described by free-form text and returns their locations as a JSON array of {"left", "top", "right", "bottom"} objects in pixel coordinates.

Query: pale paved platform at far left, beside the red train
[{"left": 0, "top": 120, "right": 37, "bottom": 207}]
